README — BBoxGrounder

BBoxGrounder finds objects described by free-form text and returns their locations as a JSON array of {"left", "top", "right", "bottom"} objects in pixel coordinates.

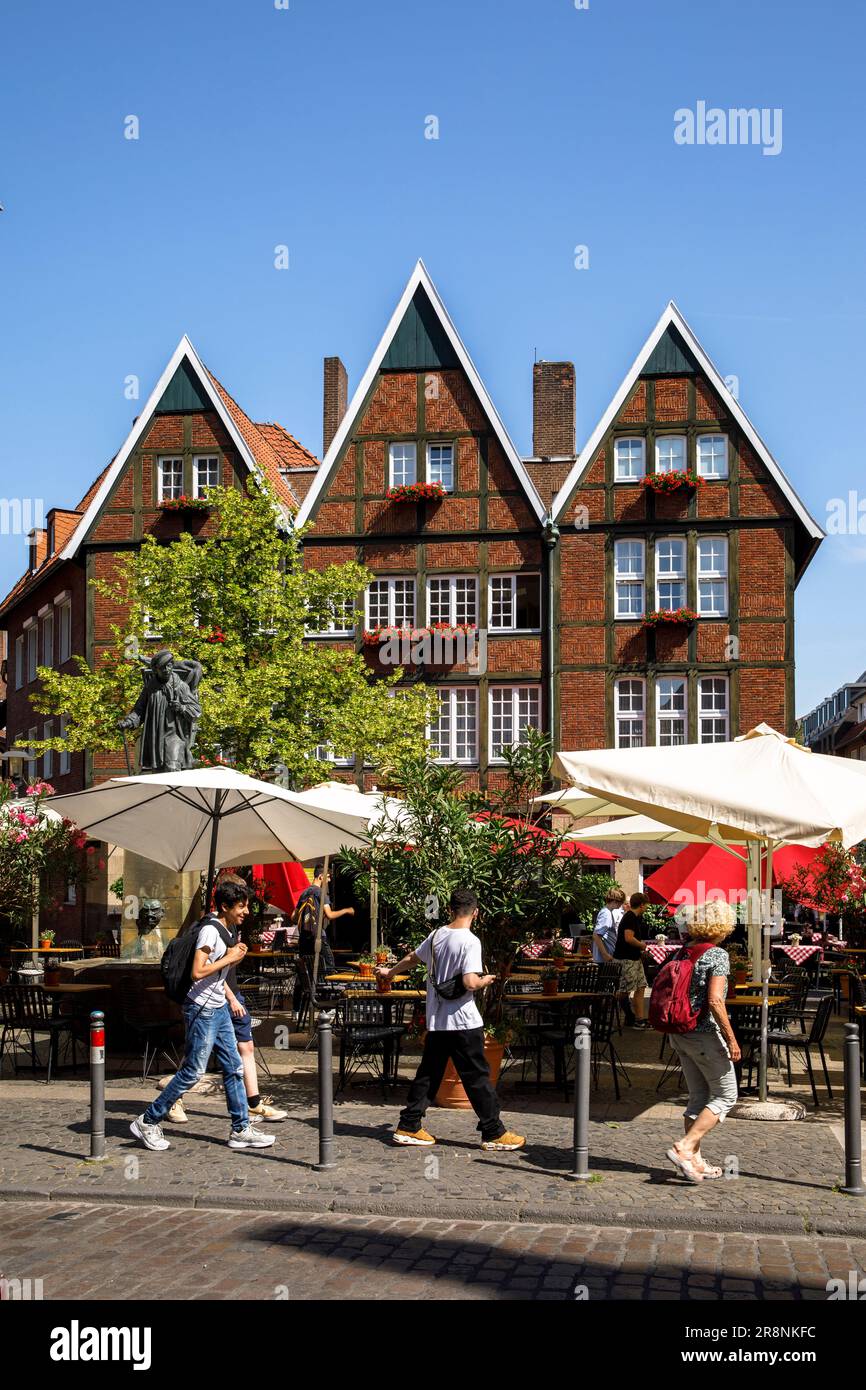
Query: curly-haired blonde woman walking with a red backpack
[{"left": 649, "top": 901, "right": 741, "bottom": 1183}]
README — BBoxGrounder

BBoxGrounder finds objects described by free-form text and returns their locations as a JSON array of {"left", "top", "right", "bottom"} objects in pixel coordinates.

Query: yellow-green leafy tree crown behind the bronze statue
[{"left": 33, "top": 485, "right": 431, "bottom": 787}]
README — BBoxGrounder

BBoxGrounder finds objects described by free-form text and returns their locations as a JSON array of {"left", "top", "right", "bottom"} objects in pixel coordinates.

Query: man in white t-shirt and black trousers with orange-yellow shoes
[{"left": 378, "top": 888, "right": 525, "bottom": 1150}]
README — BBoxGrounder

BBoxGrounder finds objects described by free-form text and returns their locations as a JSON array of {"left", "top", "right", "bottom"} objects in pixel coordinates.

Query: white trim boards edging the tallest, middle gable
[{"left": 297, "top": 260, "right": 545, "bottom": 525}]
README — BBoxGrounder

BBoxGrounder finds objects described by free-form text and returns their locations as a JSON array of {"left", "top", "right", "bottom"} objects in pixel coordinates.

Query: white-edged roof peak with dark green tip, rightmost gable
[{"left": 553, "top": 299, "right": 824, "bottom": 573}]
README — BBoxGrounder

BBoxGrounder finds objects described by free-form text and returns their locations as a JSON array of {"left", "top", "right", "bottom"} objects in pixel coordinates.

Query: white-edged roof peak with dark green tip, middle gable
[{"left": 297, "top": 261, "right": 545, "bottom": 525}]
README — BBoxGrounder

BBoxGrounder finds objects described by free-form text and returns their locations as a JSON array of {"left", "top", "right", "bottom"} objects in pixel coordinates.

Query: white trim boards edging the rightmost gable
[{"left": 552, "top": 299, "right": 824, "bottom": 541}]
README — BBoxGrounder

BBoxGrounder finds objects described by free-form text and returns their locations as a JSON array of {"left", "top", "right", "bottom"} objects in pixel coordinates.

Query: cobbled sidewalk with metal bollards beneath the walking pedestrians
[{"left": 0, "top": 1073, "right": 866, "bottom": 1237}]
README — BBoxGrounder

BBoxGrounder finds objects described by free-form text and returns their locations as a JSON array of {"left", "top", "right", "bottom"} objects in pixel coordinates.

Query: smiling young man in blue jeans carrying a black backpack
[{"left": 129, "top": 883, "right": 274, "bottom": 1152}]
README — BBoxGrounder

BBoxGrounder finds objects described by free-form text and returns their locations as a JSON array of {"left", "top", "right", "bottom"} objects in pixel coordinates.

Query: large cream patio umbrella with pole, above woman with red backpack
[{"left": 553, "top": 724, "right": 866, "bottom": 1101}]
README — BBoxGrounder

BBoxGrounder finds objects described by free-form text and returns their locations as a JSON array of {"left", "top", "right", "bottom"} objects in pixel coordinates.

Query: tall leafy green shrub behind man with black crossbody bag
[{"left": 343, "top": 731, "right": 603, "bottom": 1023}]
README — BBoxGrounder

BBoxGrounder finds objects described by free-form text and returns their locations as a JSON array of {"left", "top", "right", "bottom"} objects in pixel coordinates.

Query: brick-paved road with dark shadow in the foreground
[{"left": 0, "top": 1201, "right": 866, "bottom": 1305}]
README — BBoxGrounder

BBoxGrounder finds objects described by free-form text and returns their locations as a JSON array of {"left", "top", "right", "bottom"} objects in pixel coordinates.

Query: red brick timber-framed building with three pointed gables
[{"left": 0, "top": 263, "right": 822, "bottom": 900}]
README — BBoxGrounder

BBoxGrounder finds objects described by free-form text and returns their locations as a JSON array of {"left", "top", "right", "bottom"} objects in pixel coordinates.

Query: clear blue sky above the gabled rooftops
[{"left": 0, "top": 0, "right": 866, "bottom": 713}]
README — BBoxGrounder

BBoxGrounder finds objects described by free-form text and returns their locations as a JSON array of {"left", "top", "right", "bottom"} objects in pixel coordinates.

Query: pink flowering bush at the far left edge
[{"left": 0, "top": 781, "right": 97, "bottom": 926}]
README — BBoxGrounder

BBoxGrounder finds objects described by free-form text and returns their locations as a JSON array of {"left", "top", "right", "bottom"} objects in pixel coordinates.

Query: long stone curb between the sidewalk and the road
[{"left": 0, "top": 1186, "right": 866, "bottom": 1240}]
